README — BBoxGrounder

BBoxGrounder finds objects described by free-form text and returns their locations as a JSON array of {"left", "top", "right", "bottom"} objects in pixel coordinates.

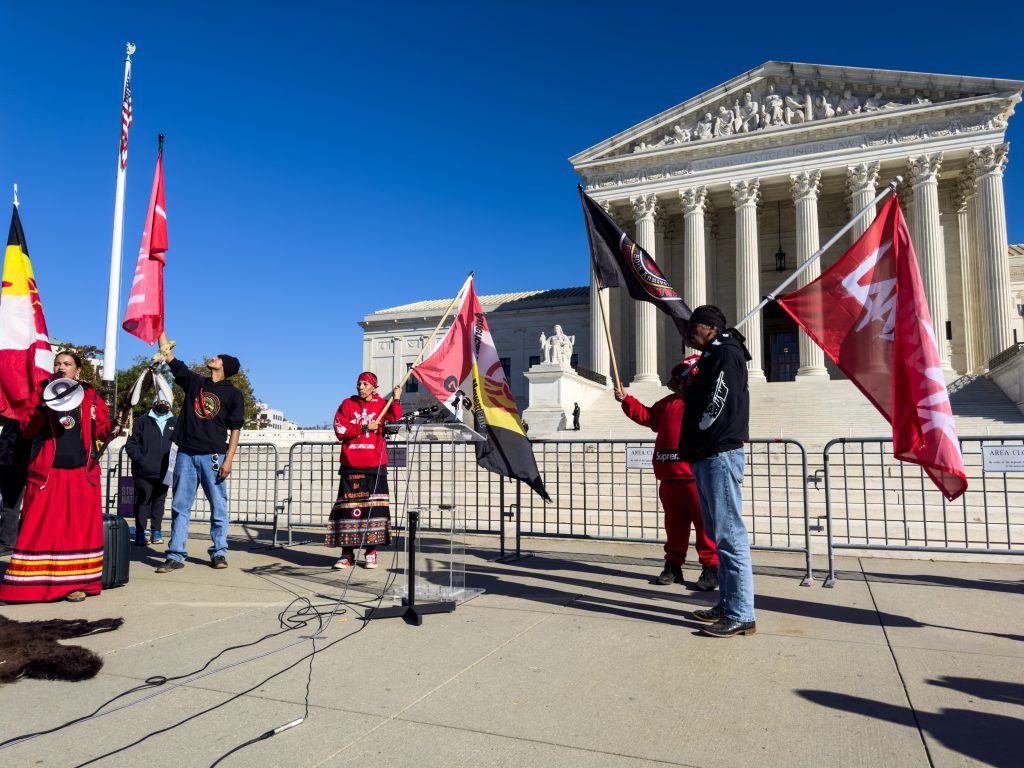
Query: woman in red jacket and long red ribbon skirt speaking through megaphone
[{"left": 0, "top": 351, "right": 111, "bottom": 602}]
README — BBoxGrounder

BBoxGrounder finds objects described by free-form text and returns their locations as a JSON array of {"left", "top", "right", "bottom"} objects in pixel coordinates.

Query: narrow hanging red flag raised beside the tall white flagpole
[{"left": 121, "top": 151, "right": 167, "bottom": 344}]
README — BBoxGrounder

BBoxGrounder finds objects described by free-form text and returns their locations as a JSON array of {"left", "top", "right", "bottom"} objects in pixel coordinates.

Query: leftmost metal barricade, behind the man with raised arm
[{"left": 105, "top": 442, "right": 287, "bottom": 546}]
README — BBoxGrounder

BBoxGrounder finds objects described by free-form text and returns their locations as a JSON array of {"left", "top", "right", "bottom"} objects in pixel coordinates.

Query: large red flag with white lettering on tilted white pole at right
[{"left": 778, "top": 197, "right": 967, "bottom": 501}]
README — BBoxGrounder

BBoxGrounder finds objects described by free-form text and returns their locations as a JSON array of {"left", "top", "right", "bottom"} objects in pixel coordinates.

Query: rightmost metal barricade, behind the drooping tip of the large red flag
[{"left": 822, "top": 435, "right": 1024, "bottom": 587}]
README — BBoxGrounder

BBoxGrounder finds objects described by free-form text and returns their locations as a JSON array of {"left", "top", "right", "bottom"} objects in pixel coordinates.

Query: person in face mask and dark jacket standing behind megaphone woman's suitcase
[{"left": 125, "top": 394, "right": 177, "bottom": 547}]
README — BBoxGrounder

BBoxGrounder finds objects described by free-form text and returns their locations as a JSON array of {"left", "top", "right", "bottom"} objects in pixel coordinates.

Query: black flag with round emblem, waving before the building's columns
[{"left": 580, "top": 185, "right": 690, "bottom": 338}]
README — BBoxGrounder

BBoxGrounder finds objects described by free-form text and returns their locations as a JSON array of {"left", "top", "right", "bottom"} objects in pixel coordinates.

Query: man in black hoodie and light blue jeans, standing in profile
[{"left": 679, "top": 304, "right": 756, "bottom": 637}]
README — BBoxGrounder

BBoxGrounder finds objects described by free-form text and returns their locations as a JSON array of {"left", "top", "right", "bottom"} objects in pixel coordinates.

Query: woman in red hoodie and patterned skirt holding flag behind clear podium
[{"left": 325, "top": 371, "right": 401, "bottom": 569}]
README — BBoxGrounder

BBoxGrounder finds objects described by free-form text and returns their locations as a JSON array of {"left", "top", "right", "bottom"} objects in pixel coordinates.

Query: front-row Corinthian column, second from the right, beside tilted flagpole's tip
[{"left": 907, "top": 153, "right": 952, "bottom": 371}]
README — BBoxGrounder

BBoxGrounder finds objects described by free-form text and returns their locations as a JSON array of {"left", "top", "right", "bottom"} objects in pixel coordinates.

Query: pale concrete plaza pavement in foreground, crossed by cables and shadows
[{"left": 0, "top": 523, "right": 1024, "bottom": 768}]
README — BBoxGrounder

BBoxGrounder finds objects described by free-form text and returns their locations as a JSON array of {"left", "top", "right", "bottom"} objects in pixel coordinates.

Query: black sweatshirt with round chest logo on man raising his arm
[{"left": 170, "top": 359, "right": 245, "bottom": 454}]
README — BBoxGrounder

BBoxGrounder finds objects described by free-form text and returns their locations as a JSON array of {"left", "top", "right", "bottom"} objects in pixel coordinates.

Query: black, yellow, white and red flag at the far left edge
[{"left": 0, "top": 208, "right": 53, "bottom": 421}]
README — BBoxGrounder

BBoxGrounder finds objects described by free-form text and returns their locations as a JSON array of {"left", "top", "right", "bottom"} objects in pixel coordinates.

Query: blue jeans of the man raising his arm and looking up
[{"left": 167, "top": 447, "right": 227, "bottom": 562}]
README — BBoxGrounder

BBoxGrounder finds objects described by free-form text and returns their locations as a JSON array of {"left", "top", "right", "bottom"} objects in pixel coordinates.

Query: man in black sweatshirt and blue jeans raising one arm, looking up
[{"left": 157, "top": 334, "right": 245, "bottom": 573}]
